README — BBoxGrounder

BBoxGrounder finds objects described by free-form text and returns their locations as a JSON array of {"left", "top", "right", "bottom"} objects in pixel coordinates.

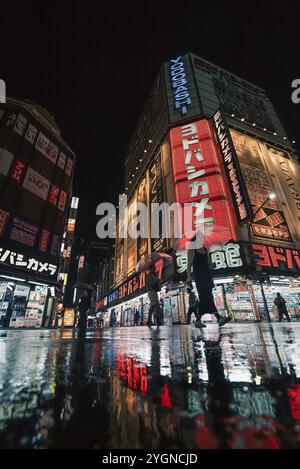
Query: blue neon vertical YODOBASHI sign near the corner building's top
[{"left": 170, "top": 57, "right": 192, "bottom": 114}]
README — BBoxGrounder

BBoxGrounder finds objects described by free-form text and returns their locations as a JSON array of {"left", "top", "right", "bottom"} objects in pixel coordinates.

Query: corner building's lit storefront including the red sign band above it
[{"left": 98, "top": 242, "right": 300, "bottom": 326}]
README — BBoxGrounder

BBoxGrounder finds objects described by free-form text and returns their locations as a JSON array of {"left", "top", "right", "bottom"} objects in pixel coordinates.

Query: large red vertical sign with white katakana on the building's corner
[{"left": 170, "top": 119, "right": 237, "bottom": 244}]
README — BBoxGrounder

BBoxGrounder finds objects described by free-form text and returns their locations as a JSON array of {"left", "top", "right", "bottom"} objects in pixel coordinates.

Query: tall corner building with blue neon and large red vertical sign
[{"left": 97, "top": 53, "right": 300, "bottom": 325}]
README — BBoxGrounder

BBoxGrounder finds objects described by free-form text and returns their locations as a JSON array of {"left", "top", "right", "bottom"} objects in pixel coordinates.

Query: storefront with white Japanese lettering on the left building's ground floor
[{"left": 0, "top": 241, "right": 59, "bottom": 328}]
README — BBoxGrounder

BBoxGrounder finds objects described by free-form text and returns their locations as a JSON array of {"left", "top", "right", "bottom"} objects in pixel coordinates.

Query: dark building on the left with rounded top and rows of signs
[{"left": 0, "top": 98, "right": 75, "bottom": 327}]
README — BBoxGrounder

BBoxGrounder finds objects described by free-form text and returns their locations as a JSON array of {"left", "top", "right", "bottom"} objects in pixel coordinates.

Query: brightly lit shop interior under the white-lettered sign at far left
[{"left": 0, "top": 275, "right": 55, "bottom": 328}]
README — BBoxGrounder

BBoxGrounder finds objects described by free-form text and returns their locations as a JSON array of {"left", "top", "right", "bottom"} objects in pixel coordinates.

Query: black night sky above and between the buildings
[{"left": 0, "top": 0, "right": 300, "bottom": 239}]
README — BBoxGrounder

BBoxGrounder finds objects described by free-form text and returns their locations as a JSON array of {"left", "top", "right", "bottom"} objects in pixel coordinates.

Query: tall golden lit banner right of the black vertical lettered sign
[{"left": 231, "top": 130, "right": 292, "bottom": 241}]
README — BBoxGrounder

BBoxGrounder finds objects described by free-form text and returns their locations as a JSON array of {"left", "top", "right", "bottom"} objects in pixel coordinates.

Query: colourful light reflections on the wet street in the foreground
[{"left": 0, "top": 323, "right": 300, "bottom": 449}]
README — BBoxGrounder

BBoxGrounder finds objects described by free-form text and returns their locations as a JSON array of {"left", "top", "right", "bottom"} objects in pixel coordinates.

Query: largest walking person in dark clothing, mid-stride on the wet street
[{"left": 188, "top": 246, "right": 231, "bottom": 327}]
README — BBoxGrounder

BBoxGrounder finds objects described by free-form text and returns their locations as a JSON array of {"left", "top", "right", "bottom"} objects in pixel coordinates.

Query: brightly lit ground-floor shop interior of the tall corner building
[{"left": 97, "top": 275, "right": 300, "bottom": 327}]
